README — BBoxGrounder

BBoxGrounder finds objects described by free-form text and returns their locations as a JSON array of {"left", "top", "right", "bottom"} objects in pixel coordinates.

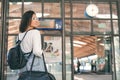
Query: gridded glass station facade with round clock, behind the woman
[{"left": 0, "top": 0, "right": 120, "bottom": 80}]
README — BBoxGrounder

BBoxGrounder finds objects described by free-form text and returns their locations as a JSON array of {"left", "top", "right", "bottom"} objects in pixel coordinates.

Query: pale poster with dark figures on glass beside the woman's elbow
[{"left": 43, "top": 37, "right": 62, "bottom": 63}]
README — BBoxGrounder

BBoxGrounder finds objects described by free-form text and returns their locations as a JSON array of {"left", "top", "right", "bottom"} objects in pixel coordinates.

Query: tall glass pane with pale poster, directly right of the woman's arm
[{"left": 43, "top": 36, "right": 62, "bottom": 80}]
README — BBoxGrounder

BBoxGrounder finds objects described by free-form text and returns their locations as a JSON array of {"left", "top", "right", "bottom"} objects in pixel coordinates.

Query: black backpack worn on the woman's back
[{"left": 7, "top": 32, "right": 32, "bottom": 70}]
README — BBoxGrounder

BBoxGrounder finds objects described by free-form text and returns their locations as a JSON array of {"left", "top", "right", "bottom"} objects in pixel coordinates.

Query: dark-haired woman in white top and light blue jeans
[{"left": 19, "top": 10, "right": 45, "bottom": 72}]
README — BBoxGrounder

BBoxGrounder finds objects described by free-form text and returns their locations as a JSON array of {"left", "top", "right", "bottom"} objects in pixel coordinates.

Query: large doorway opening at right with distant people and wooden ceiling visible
[{"left": 73, "top": 36, "right": 113, "bottom": 80}]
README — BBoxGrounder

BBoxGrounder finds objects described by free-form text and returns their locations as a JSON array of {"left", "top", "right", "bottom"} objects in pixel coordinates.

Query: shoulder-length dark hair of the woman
[{"left": 19, "top": 10, "right": 35, "bottom": 32}]
